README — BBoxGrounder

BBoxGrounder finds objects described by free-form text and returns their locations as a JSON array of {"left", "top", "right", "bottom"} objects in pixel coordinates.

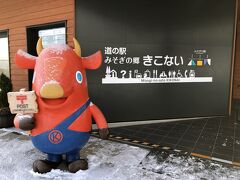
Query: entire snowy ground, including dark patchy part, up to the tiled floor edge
[{"left": 0, "top": 132, "right": 240, "bottom": 180}]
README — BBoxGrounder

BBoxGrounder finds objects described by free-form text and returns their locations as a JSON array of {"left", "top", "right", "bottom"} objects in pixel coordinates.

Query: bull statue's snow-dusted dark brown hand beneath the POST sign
[{"left": 17, "top": 115, "right": 35, "bottom": 131}]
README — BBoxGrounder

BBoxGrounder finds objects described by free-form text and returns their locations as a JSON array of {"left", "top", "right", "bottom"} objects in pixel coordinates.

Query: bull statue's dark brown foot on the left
[{"left": 33, "top": 160, "right": 60, "bottom": 173}]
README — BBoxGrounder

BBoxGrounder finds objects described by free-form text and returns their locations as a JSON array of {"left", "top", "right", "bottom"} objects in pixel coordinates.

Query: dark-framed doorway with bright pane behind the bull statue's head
[{"left": 27, "top": 21, "right": 66, "bottom": 90}]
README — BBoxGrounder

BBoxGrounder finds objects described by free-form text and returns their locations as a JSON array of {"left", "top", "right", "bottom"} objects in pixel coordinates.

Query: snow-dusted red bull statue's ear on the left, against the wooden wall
[{"left": 14, "top": 50, "right": 37, "bottom": 69}]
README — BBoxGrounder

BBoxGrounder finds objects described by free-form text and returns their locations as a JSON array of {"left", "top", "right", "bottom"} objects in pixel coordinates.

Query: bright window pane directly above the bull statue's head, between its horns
[{"left": 38, "top": 27, "right": 66, "bottom": 48}]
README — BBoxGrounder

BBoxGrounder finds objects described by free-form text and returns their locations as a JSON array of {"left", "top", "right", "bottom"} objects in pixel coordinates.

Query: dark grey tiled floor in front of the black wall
[{"left": 107, "top": 111, "right": 240, "bottom": 162}]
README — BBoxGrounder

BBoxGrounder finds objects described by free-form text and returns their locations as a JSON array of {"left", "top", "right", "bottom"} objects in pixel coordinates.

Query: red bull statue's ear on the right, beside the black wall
[{"left": 81, "top": 51, "right": 102, "bottom": 69}]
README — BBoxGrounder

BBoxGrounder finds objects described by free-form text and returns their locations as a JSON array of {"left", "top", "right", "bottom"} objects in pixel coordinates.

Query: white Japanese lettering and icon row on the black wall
[{"left": 102, "top": 47, "right": 213, "bottom": 84}]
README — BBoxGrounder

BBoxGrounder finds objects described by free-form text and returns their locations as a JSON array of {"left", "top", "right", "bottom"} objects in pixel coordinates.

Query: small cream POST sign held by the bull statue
[{"left": 8, "top": 90, "right": 38, "bottom": 114}]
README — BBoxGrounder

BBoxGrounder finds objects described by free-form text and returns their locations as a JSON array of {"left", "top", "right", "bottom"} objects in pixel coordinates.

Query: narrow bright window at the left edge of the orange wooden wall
[{"left": 0, "top": 31, "right": 10, "bottom": 77}]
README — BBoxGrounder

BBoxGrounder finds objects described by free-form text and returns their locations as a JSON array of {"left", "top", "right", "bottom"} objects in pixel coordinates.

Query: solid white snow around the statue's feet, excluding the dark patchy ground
[{"left": 0, "top": 135, "right": 154, "bottom": 180}]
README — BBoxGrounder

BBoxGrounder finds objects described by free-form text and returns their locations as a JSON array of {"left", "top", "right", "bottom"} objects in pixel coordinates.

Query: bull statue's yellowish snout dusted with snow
[{"left": 40, "top": 82, "right": 64, "bottom": 99}]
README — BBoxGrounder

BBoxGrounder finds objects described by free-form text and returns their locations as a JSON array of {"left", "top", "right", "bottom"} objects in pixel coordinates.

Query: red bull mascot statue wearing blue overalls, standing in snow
[{"left": 14, "top": 38, "right": 109, "bottom": 173}]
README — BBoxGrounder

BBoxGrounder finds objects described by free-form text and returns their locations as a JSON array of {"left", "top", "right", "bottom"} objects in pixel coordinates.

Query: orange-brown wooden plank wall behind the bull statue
[{"left": 0, "top": 0, "right": 75, "bottom": 90}]
